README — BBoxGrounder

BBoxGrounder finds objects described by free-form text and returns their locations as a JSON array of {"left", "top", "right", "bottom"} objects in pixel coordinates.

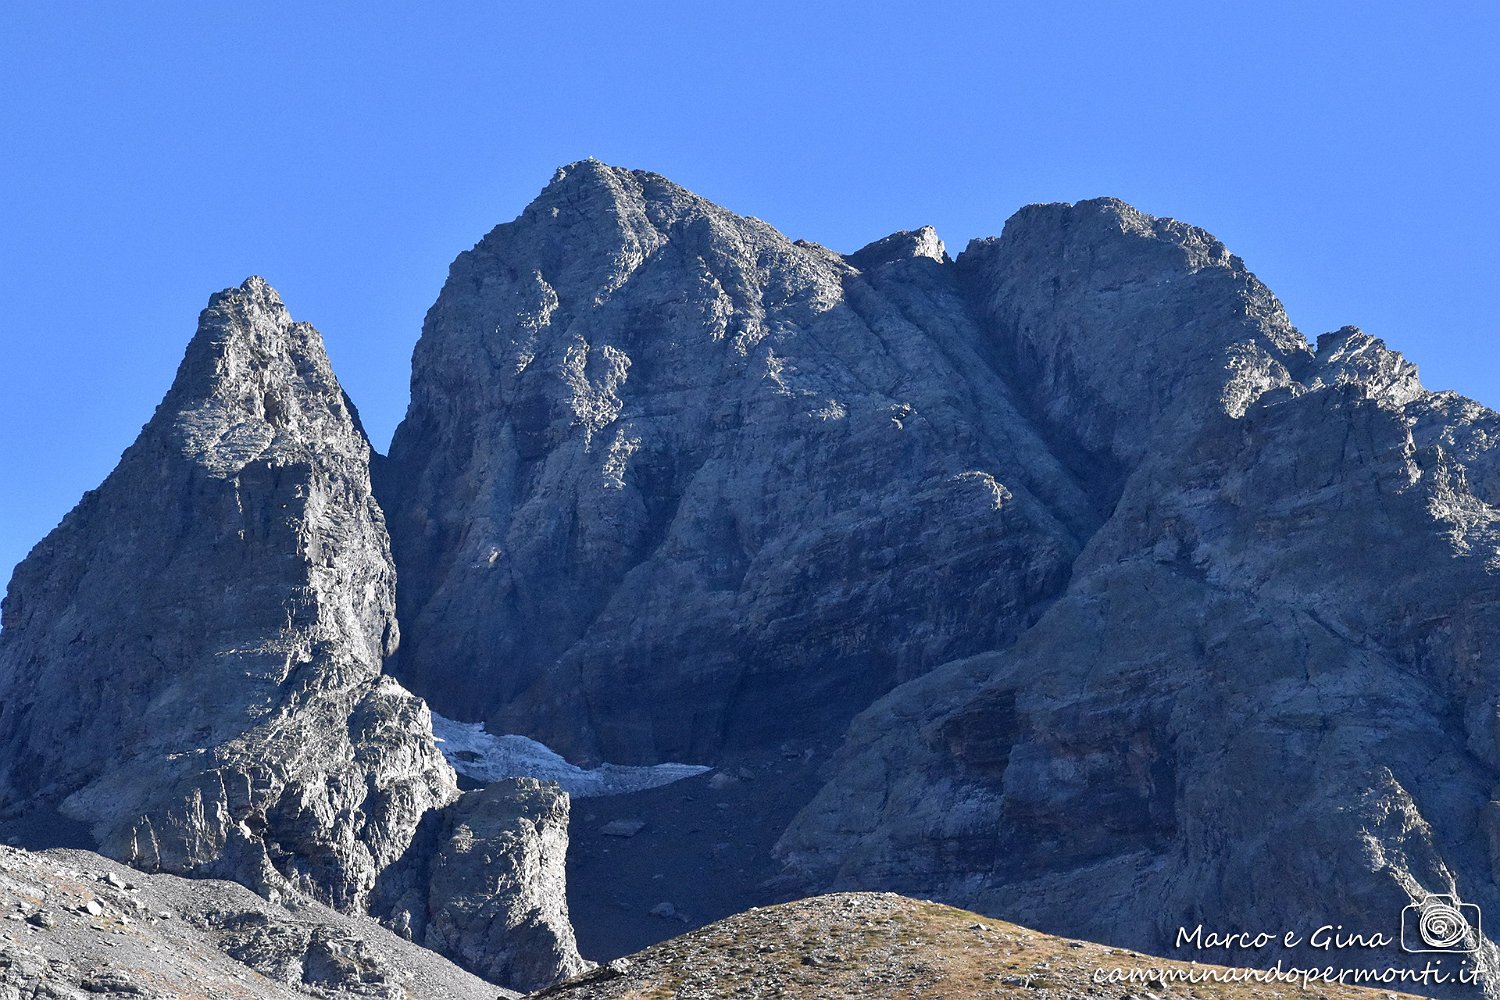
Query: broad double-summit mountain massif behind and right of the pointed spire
[{"left": 378, "top": 162, "right": 1500, "bottom": 970}]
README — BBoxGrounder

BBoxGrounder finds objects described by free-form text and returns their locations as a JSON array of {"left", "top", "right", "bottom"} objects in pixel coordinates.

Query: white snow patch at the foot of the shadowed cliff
[{"left": 432, "top": 712, "right": 713, "bottom": 799}]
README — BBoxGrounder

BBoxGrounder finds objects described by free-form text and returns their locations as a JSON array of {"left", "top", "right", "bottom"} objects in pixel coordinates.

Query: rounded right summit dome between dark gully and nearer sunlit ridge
[{"left": 959, "top": 198, "right": 1310, "bottom": 472}]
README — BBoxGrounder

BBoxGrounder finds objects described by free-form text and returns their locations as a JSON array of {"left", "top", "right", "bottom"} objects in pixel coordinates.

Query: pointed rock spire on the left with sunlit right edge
[{"left": 0, "top": 279, "right": 456, "bottom": 910}]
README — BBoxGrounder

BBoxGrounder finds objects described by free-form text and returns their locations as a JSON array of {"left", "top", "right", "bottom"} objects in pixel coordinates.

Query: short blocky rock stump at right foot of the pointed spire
[{"left": 374, "top": 778, "right": 591, "bottom": 993}]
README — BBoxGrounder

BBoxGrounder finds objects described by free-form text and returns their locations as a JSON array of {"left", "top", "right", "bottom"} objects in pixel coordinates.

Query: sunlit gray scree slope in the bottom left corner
[{"left": 0, "top": 847, "right": 516, "bottom": 1000}]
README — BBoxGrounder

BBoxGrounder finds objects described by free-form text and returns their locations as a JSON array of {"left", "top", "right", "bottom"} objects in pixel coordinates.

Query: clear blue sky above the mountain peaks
[{"left": 0, "top": 0, "right": 1500, "bottom": 579}]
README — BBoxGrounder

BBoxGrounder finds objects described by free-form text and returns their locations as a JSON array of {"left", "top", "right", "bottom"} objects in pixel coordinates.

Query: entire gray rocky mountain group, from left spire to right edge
[{"left": 0, "top": 160, "right": 1500, "bottom": 996}]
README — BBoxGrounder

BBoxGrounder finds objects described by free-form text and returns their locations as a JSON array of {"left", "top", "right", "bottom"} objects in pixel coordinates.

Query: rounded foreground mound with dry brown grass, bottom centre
[{"left": 536, "top": 894, "right": 1434, "bottom": 1000}]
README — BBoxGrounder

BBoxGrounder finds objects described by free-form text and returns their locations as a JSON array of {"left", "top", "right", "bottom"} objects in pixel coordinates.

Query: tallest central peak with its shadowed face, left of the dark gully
[{"left": 380, "top": 160, "right": 1098, "bottom": 763}]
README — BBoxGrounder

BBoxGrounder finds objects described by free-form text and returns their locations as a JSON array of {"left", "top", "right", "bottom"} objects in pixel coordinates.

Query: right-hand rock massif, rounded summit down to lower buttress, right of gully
[{"left": 779, "top": 202, "right": 1500, "bottom": 976}]
